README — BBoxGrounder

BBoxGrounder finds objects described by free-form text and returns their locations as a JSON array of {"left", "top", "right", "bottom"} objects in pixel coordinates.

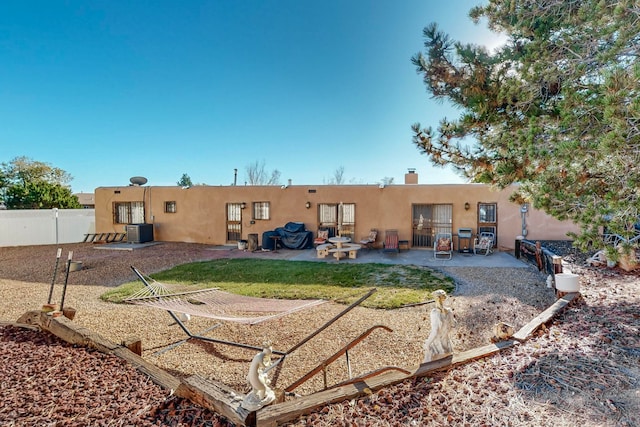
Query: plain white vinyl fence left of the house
[{"left": 0, "top": 209, "right": 96, "bottom": 247}]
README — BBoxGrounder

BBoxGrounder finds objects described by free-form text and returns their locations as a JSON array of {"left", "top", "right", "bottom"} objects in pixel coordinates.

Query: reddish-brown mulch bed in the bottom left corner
[{"left": 0, "top": 325, "right": 230, "bottom": 426}]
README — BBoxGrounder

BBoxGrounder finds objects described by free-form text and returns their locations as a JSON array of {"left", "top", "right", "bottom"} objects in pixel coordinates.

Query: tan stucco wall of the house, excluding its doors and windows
[{"left": 95, "top": 184, "right": 577, "bottom": 249}]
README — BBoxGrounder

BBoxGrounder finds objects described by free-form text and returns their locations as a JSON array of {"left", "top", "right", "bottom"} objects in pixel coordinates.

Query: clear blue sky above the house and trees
[{"left": 0, "top": 0, "right": 498, "bottom": 192}]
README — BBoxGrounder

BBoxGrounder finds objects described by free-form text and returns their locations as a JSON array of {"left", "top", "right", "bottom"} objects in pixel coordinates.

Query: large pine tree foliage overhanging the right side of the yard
[{"left": 412, "top": 0, "right": 640, "bottom": 249}]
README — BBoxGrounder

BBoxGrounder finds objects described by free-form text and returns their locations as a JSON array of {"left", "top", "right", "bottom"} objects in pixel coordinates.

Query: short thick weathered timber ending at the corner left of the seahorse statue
[{"left": 176, "top": 375, "right": 256, "bottom": 426}]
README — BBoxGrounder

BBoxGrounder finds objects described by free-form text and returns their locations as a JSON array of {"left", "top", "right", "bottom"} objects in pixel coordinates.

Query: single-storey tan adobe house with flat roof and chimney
[{"left": 95, "top": 170, "right": 578, "bottom": 250}]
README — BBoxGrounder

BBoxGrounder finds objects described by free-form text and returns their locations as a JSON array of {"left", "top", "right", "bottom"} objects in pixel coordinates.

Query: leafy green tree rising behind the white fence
[{"left": 0, "top": 156, "right": 82, "bottom": 209}]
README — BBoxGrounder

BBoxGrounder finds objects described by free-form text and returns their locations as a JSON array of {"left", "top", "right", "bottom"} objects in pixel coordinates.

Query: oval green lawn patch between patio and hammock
[{"left": 101, "top": 259, "right": 454, "bottom": 309}]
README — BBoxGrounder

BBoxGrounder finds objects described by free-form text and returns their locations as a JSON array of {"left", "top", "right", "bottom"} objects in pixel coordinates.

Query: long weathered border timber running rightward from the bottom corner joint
[{"left": 256, "top": 340, "right": 518, "bottom": 427}]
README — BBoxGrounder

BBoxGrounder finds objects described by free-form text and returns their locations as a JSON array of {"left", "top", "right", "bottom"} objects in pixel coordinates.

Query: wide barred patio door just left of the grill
[{"left": 411, "top": 204, "right": 453, "bottom": 248}]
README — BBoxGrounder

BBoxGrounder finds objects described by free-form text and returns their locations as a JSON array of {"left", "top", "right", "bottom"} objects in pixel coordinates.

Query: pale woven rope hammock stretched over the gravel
[{"left": 125, "top": 279, "right": 326, "bottom": 325}]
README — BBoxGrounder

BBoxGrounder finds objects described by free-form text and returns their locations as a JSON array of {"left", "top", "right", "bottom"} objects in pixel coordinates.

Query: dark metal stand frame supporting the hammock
[{"left": 130, "top": 266, "right": 376, "bottom": 360}]
